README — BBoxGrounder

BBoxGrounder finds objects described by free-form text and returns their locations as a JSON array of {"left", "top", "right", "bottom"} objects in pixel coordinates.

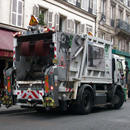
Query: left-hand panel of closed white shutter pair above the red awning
[{"left": 12, "top": 0, "right": 17, "bottom": 25}]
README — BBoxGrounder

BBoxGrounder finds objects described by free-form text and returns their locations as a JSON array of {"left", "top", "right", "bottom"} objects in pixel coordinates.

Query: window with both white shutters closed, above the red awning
[{"left": 11, "top": 0, "right": 23, "bottom": 27}]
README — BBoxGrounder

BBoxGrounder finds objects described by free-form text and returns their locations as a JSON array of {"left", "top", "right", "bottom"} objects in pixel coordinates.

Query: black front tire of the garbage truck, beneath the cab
[{"left": 113, "top": 90, "right": 124, "bottom": 109}]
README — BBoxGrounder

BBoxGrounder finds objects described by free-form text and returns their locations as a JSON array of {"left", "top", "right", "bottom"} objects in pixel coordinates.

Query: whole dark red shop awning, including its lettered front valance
[{"left": 0, "top": 29, "right": 13, "bottom": 57}]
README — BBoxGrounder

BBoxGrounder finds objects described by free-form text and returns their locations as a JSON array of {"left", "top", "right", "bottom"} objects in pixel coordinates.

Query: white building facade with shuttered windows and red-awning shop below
[{"left": 0, "top": 0, "right": 97, "bottom": 96}]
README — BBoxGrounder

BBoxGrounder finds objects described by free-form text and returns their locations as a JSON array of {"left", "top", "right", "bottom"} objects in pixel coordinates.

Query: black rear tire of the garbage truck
[{"left": 76, "top": 90, "right": 92, "bottom": 114}]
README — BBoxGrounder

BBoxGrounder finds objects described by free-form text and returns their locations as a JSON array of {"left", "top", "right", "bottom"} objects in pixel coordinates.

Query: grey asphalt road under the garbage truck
[{"left": 0, "top": 100, "right": 130, "bottom": 130}]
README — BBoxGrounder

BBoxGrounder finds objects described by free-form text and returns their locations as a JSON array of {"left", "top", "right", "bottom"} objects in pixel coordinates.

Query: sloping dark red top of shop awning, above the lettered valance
[{"left": 0, "top": 29, "right": 13, "bottom": 51}]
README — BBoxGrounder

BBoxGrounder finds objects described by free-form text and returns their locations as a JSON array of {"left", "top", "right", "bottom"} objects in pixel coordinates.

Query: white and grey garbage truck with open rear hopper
[{"left": 2, "top": 16, "right": 125, "bottom": 114}]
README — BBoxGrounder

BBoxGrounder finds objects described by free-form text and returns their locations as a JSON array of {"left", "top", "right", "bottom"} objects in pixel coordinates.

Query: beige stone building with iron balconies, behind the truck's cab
[{"left": 96, "top": 0, "right": 130, "bottom": 73}]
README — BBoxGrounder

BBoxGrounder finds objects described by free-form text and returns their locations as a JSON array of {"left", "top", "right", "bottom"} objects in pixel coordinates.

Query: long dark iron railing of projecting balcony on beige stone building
[{"left": 116, "top": 19, "right": 130, "bottom": 33}]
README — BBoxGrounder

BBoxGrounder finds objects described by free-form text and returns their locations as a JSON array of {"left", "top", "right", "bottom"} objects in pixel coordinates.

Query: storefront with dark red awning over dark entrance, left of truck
[{"left": 0, "top": 29, "right": 13, "bottom": 97}]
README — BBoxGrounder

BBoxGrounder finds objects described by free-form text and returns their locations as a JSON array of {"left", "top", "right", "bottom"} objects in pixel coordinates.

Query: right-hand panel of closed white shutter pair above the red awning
[{"left": 17, "top": 1, "right": 23, "bottom": 26}]
